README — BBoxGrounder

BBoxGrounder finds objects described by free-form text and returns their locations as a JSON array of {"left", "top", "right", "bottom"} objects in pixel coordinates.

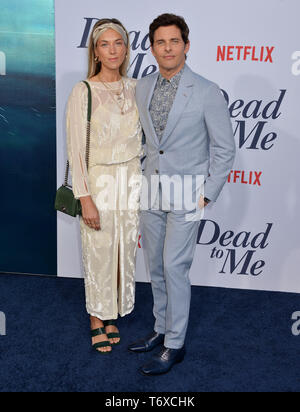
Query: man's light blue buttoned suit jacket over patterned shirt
[{"left": 136, "top": 65, "right": 236, "bottom": 211}]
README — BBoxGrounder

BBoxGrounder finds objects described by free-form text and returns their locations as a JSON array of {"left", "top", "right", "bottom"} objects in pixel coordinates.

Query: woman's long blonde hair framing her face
[{"left": 88, "top": 19, "right": 130, "bottom": 79}]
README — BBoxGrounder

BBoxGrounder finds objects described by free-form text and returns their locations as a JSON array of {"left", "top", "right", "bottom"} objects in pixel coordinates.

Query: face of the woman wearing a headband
[{"left": 95, "top": 29, "right": 127, "bottom": 71}]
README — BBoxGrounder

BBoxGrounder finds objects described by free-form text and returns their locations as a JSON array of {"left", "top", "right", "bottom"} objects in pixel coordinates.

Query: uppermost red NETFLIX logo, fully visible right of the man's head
[{"left": 217, "top": 46, "right": 275, "bottom": 63}]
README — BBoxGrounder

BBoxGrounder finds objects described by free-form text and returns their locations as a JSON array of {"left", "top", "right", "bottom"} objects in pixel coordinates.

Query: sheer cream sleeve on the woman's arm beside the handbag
[{"left": 66, "top": 83, "right": 90, "bottom": 199}]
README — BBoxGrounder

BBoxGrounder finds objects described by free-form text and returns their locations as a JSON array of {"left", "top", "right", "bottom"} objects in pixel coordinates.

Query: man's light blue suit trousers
[{"left": 141, "top": 190, "right": 200, "bottom": 349}]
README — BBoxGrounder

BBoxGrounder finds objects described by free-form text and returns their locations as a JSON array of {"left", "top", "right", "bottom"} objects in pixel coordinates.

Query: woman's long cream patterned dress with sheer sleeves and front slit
[{"left": 67, "top": 78, "right": 142, "bottom": 320}]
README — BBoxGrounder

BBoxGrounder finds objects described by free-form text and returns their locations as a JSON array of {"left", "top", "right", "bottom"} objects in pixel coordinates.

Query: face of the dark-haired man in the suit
[{"left": 151, "top": 26, "right": 190, "bottom": 71}]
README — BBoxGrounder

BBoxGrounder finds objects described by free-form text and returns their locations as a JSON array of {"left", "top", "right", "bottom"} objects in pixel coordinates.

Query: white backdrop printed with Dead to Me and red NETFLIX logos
[{"left": 56, "top": 0, "right": 300, "bottom": 292}]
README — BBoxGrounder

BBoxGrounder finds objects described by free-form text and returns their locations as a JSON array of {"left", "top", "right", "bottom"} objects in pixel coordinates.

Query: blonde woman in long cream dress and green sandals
[{"left": 67, "top": 19, "right": 142, "bottom": 353}]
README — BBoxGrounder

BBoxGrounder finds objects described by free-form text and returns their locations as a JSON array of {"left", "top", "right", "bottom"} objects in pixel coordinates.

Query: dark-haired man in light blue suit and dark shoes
[{"left": 129, "top": 14, "right": 235, "bottom": 375}]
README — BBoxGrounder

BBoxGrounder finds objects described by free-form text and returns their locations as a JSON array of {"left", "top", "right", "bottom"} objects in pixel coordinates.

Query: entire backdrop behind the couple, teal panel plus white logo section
[{"left": 0, "top": 0, "right": 300, "bottom": 293}]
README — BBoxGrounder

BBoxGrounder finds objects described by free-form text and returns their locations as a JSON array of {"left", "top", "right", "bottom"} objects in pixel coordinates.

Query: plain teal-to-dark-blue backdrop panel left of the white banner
[{"left": 0, "top": 0, "right": 57, "bottom": 275}]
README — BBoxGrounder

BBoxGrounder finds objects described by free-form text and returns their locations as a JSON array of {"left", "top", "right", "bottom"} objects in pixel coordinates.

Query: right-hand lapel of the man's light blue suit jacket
[{"left": 161, "top": 65, "right": 194, "bottom": 143}]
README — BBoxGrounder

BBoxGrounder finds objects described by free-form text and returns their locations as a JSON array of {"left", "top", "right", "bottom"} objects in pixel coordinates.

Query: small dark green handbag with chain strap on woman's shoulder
[{"left": 54, "top": 82, "right": 92, "bottom": 217}]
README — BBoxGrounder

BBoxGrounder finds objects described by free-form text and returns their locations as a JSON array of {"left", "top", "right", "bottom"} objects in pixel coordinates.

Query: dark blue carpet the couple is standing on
[{"left": 0, "top": 275, "right": 300, "bottom": 392}]
